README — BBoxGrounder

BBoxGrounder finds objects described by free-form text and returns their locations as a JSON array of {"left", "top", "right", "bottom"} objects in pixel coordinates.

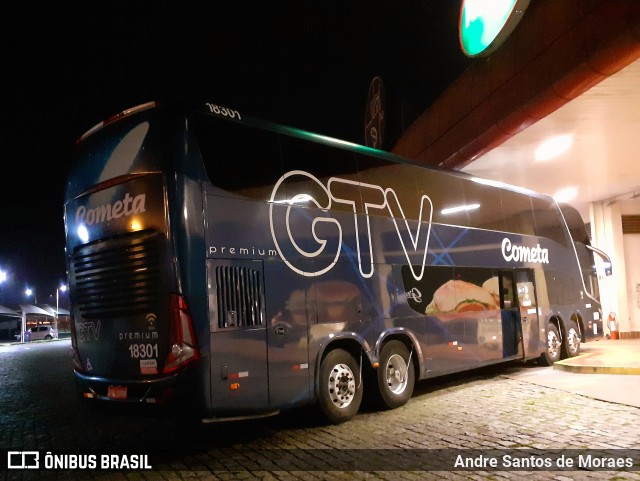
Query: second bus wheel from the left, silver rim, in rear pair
[{"left": 376, "top": 340, "right": 415, "bottom": 409}]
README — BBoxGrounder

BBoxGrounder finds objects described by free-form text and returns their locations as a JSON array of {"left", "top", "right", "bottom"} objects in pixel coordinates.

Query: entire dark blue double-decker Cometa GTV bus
[{"left": 65, "top": 102, "right": 603, "bottom": 423}]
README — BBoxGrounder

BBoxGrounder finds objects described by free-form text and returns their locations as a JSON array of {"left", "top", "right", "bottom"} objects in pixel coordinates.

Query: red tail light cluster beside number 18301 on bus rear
[{"left": 164, "top": 294, "right": 200, "bottom": 374}]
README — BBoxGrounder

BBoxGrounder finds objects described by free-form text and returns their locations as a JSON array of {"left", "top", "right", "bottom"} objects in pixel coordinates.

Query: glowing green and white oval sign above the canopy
[{"left": 458, "top": 0, "right": 529, "bottom": 57}]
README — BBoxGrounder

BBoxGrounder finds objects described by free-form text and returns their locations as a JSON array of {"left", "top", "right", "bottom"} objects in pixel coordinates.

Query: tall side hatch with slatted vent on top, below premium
[{"left": 207, "top": 259, "right": 269, "bottom": 415}]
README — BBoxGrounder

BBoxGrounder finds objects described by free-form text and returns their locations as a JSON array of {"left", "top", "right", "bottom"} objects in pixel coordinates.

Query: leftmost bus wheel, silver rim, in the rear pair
[{"left": 318, "top": 349, "right": 362, "bottom": 424}]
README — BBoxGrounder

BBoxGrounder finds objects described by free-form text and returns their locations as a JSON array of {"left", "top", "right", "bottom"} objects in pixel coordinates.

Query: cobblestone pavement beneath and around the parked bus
[{"left": 0, "top": 341, "right": 640, "bottom": 481}]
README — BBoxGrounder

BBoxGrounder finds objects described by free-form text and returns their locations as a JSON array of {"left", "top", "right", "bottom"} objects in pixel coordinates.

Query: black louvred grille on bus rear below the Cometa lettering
[{"left": 71, "top": 231, "right": 160, "bottom": 319}]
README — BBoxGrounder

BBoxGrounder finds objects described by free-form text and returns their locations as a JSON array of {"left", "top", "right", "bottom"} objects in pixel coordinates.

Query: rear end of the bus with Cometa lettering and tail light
[{"left": 65, "top": 103, "right": 199, "bottom": 403}]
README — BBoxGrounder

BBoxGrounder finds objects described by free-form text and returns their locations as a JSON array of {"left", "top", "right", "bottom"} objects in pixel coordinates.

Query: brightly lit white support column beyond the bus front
[{"left": 590, "top": 202, "right": 632, "bottom": 333}]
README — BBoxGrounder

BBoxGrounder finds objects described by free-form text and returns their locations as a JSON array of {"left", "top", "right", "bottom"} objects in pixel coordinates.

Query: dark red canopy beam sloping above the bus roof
[{"left": 392, "top": 0, "right": 640, "bottom": 169}]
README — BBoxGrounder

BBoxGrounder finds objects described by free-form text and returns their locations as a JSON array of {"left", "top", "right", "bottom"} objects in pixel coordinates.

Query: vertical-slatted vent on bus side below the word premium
[{"left": 215, "top": 266, "right": 263, "bottom": 328}]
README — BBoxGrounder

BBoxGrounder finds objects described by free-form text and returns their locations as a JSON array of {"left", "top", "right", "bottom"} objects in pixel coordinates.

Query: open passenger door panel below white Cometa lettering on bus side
[{"left": 514, "top": 269, "right": 540, "bottom": 358}]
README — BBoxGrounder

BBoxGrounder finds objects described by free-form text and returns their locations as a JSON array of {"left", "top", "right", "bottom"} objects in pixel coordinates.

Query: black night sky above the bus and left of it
[{"left": 0, "top": 0, "right": 468, "bottom": 303}]
